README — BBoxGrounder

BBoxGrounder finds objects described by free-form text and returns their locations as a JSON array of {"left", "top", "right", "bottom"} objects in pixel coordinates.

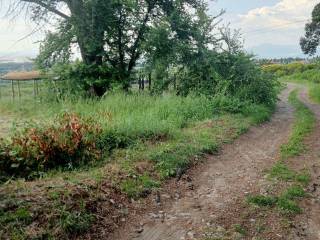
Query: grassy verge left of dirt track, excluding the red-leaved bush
[{"left": 0, "top": 91, "right": 272, "bottom": 239}]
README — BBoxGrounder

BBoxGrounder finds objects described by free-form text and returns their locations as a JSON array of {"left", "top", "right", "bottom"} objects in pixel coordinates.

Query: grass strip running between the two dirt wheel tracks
[{"left": 247, "top": 90, "right": 316, "bottom": 214}]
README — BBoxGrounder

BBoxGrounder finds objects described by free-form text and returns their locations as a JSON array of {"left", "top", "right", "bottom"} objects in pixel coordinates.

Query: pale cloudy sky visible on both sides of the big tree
[{"left": 0, "top": 0, "right": 319, "bottom": 60}]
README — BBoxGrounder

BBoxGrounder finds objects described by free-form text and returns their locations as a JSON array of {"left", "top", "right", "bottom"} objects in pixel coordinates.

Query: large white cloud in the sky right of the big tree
[{"left": 232, "top": 0, "right": 319, "bottom": 48}]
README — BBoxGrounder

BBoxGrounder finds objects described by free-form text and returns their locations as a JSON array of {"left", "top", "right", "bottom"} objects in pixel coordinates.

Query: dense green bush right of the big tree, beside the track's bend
[{"left": 175, "top": 52, "right": 279, "bottom": 106}]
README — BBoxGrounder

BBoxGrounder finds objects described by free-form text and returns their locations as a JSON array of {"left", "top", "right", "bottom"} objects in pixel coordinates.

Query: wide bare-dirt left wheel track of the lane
[{"left": 114, "top": 85, "right": 294, "bottom": 240}]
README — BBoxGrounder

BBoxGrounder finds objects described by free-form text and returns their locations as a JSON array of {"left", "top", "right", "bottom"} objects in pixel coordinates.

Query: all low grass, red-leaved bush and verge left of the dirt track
[{"left": 0, "top": 79, "right": 273, "bottom": 239}]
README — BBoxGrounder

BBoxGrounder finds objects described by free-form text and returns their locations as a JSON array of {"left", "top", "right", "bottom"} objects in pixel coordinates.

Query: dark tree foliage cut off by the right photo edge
[{"left": 300, "top": 4, "right": 320, "bottom": 55}]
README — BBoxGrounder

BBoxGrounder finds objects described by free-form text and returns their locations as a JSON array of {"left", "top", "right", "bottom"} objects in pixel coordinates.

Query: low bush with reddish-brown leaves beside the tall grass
[{"left": 0, "top": 113, "right": 102, "bottom": 180}]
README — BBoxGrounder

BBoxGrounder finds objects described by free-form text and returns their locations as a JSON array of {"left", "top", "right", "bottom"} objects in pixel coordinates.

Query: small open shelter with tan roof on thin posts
[{"left": 0, "top": 71, "right": 42, "bottom": 99}]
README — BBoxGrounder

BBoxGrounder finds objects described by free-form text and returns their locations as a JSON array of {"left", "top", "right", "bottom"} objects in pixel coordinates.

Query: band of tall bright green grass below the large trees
[{"left": 0, "top": 93, "right": 270, "bottom": 141}]
